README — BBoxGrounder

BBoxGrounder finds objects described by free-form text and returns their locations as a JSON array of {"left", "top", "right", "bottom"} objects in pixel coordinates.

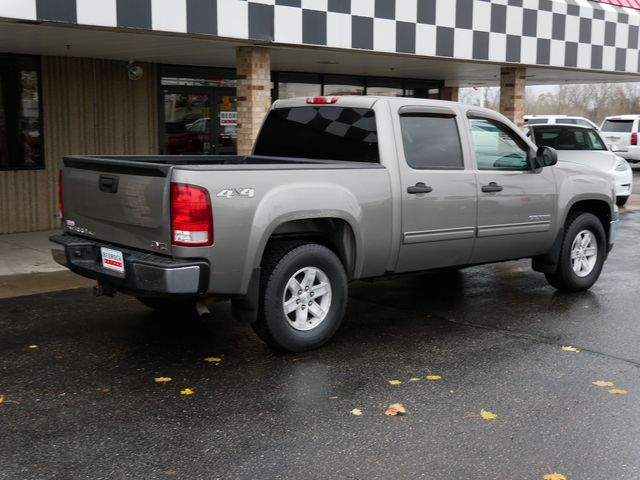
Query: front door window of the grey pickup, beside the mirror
[{"left": 469, "top": 117, "right": 531, "bottom": 170}]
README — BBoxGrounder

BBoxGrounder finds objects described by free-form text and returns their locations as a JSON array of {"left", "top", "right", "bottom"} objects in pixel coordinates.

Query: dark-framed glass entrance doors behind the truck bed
[{"left": 161, "top": 86, "right": 237, "bottom": 155}]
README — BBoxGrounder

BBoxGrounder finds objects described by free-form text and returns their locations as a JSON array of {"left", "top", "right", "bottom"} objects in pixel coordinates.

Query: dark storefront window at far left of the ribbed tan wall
[{"left": 0, "top": 55, "right": 44, "bottom": 170}]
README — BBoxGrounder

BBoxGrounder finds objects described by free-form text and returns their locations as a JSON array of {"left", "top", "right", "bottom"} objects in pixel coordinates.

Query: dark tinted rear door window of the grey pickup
[{"left": 400, "top": 114, "right": 464, "bottom": 170}]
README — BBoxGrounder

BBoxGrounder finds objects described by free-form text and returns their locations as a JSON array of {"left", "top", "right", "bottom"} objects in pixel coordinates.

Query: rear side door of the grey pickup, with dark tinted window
[{"left": 397, "top": 107, "right": 477, "bottom": 272}]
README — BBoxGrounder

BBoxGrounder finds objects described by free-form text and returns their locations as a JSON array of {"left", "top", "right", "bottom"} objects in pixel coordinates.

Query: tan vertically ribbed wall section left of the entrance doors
[{"left": 0, "top": 57, "right": 159, "bottom": 234}]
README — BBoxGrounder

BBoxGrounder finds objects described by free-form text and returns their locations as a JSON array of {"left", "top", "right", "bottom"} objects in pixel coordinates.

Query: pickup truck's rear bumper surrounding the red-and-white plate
[{"left": 49, "top": 235, "right": 209, "bottom": 296}]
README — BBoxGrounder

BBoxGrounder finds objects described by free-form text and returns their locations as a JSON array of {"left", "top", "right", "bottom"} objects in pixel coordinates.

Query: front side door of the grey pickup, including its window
[{"left": 469, "top": 113, "right": 557, "bottom": 263}]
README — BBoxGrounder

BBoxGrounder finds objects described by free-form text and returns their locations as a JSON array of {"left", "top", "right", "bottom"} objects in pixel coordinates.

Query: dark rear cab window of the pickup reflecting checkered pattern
[{"left": 254, "top": 106, "right": 380, "bottom": 163}]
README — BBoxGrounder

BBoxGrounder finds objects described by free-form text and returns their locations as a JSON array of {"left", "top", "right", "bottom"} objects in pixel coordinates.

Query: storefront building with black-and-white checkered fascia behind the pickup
[{"left": 0, "top": 0, "right": 640, "bottom": 233}]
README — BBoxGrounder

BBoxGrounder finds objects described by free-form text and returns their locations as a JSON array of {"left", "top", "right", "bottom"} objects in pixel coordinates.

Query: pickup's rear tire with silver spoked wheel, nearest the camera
[{"left": 252, "top": 242, "right": 348, "bottom": 352}]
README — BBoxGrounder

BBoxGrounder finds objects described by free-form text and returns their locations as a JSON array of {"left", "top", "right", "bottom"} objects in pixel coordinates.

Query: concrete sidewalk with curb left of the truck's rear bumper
[{"left": 0, "top": 230, "right": 95, "bottom": 298}]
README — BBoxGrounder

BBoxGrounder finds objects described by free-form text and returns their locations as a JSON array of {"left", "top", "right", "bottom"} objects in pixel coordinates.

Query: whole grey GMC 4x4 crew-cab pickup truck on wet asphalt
[{"left": 51, "top": 97, "right": 618, "bottom": 352}]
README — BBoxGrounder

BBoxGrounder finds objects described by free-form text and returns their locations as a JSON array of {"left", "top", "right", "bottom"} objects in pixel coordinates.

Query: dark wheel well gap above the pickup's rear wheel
[{"left": 265, "top": 218, "right": 356, "bottom": 278}]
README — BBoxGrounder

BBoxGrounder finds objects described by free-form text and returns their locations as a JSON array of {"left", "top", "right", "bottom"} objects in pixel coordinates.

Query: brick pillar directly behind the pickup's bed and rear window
[{"left": 236, "top": 47, "right": 271, "bottom": 155}]
